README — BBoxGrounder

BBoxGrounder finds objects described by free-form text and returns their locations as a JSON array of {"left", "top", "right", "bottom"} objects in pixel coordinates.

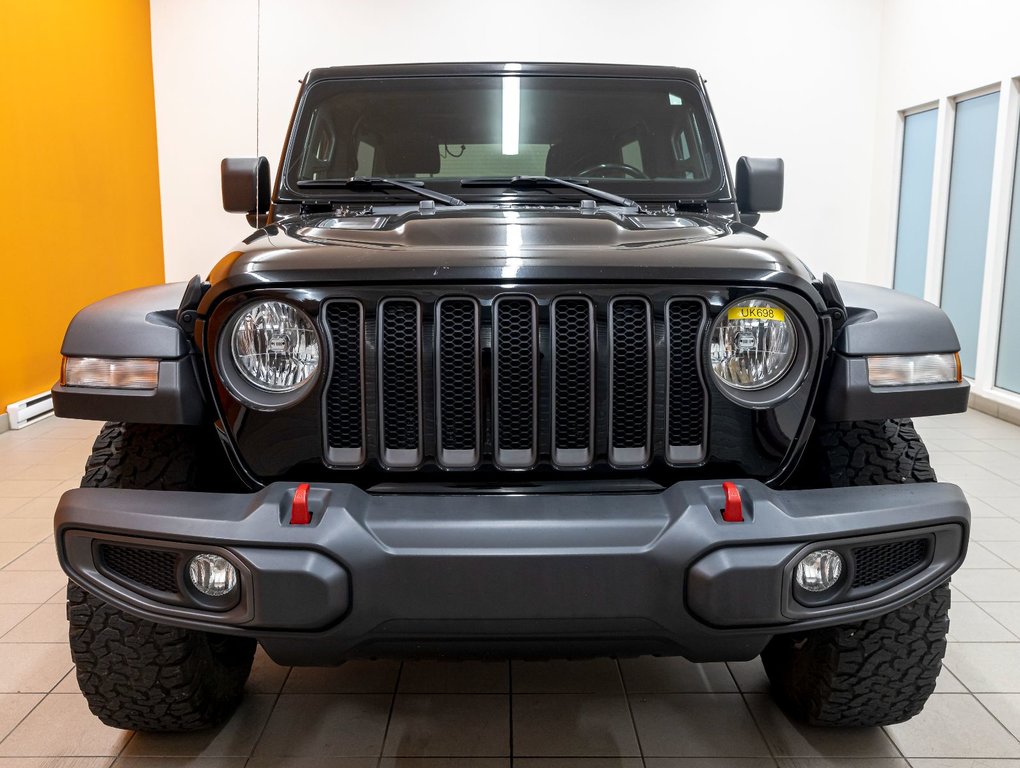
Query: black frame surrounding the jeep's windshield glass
[{"left": 273, "top": 71, "right": 733, "bottom": 205}]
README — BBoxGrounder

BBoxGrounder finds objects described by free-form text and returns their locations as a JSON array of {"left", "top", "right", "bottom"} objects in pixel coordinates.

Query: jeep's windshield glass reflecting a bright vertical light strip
[{"left": 282, "top": 74, "right": 724, "bottom": 200}]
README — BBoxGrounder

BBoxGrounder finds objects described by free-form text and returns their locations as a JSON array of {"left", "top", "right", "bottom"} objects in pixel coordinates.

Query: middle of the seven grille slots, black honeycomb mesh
[{"left": 493, "top": 296, "right": 539, "bottom": 469}]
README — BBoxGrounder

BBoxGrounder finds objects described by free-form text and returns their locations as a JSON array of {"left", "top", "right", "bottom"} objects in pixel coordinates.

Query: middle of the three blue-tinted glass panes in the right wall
[{"left": 942, "top": 93, "right": 999, "bottom": 376}]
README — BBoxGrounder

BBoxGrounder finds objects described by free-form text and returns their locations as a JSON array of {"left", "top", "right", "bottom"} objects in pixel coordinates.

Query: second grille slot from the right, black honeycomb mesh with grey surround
[{"left": 609, "top": 298, "right": 652, "bottom": 467}]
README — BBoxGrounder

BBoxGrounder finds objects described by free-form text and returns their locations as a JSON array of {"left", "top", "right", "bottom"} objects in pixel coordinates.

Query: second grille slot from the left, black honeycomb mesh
[{"left": 378, "top": 299, "right": 422, "bottom": 468}]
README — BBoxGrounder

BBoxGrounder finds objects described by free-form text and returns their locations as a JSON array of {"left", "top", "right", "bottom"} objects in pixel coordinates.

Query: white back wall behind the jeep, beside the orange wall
[{"left": 151, "top": 0, "right": 882, "bottom": 279}]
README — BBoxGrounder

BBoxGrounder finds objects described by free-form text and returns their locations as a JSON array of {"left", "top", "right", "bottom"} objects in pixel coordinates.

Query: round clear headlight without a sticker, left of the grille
[{"left": 231, "top": 301, "right": 319, "bottom": 393}]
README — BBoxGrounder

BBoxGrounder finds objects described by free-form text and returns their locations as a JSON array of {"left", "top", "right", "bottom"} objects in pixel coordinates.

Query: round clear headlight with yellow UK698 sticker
[{"left": 711, "top": 299, "right": 797, "bottom": 390}]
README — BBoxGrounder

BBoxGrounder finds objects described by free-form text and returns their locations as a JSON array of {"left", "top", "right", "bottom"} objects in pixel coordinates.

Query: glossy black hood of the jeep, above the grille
[{"left": 202, "top": 206, "right": 815, "bottom": 308}]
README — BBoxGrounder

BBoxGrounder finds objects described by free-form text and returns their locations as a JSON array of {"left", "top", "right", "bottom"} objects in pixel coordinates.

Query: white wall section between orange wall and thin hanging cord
[{"left": 150, "top": 0, "right": 258, "bottom": 281}]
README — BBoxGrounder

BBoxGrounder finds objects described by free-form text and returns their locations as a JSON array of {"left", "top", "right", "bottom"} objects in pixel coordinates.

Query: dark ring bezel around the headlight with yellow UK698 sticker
[{"left": 704, "top": 293, "right": 813, "bottom": 410}]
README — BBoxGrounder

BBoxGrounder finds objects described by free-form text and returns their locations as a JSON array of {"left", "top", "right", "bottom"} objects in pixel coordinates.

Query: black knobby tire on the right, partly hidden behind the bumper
[{"left": 762, "top": 419, "right": 950, "bottom": 726}]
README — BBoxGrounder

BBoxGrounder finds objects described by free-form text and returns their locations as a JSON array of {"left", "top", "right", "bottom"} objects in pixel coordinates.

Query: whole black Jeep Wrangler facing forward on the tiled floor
[{"left": 53, "top": 63, "right": 969, "bottom": 730}]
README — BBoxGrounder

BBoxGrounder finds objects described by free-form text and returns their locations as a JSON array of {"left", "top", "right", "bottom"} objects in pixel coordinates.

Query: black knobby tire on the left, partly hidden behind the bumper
[{"left": 67, "top": 422, "right": 255, "bottom": 731}]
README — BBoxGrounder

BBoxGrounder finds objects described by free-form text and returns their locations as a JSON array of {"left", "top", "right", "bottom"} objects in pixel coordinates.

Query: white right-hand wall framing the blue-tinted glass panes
[{"left": 868, "top": 0, "right": 1020, "bottom": 408}]
